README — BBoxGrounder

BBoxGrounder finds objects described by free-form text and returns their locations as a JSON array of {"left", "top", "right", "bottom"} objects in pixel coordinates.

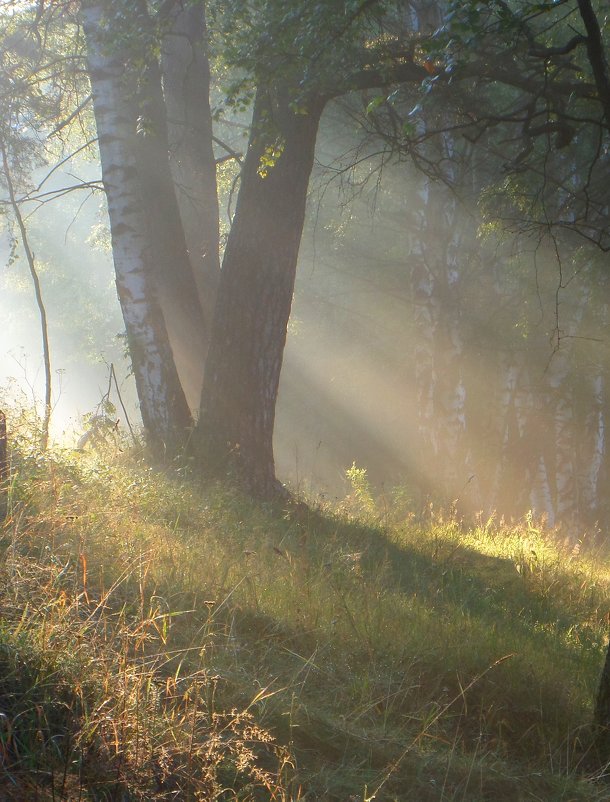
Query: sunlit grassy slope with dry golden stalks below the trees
[{"left": 0, "top": 440, "right": 610, "bottom": 802}]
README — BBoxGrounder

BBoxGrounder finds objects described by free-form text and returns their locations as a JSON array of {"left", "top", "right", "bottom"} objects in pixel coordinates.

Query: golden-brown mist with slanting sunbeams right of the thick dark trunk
[{"left": 276, "top": 103, "right": 608, "bottom": 530}]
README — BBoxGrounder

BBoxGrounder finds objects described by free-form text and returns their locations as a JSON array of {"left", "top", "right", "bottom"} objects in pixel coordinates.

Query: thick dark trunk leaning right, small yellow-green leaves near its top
[{"left": 194, "top": 89, "right": 324, "bottom": 497}]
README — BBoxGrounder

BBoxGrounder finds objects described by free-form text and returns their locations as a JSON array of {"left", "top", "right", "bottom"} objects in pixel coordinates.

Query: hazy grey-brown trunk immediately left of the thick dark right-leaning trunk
[{"left": 161, "top": 3, "right": 220, "bottom": 332}]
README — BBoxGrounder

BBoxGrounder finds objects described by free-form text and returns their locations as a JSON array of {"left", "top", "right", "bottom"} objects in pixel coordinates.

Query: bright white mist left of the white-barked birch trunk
[{"left": 0, "top": 156, "right": 138, "bottom": 447}]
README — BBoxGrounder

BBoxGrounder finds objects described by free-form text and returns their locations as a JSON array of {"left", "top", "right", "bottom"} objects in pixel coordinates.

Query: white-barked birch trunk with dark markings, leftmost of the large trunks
[{"left": 82, "top": 0, "right": 191, "bottom": 455}]
